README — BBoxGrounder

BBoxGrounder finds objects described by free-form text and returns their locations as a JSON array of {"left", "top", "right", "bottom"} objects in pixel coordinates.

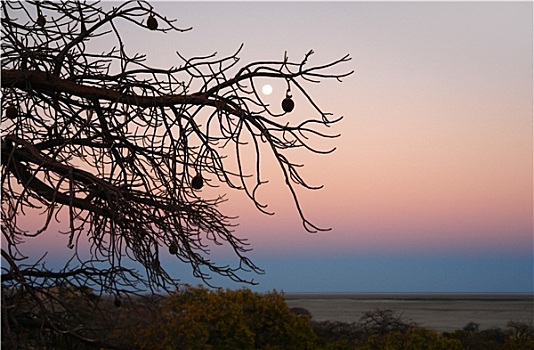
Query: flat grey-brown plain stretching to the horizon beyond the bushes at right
[{"left": 285, "top": 293, "right": 534, "bottom": 332}]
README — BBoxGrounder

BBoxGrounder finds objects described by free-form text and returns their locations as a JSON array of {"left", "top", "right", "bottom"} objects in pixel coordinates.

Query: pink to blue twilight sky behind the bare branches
[{"left": 6, "top": 2, "right": 534, "bottom": 293}]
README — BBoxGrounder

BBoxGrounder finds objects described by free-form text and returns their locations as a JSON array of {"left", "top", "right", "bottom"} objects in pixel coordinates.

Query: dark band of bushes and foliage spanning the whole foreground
[{"left": 2, "top": 286, "right": 534, "bottom": 350}]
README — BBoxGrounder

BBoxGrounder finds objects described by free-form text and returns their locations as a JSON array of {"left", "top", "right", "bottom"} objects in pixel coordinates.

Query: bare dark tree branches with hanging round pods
[{"left": 1, "top": 1, "right": 352, "bottom": 348}]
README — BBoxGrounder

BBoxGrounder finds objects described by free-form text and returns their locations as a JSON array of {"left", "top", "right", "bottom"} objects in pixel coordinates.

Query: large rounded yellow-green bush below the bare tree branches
[{"left": 135, "top": 286, "right": 316, "bottom": 350}]
